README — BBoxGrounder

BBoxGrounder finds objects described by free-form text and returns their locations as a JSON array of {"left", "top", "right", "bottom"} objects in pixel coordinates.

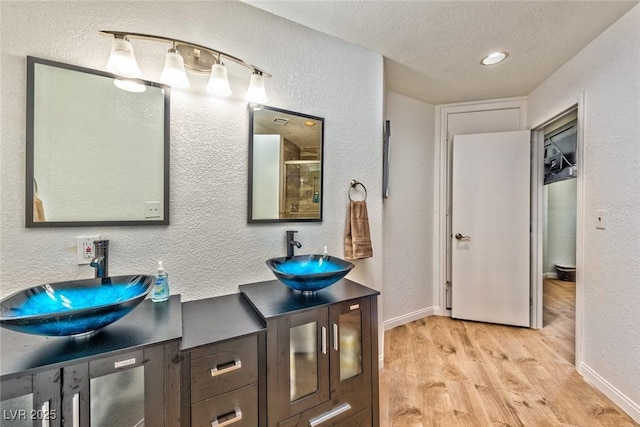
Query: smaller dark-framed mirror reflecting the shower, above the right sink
[{"left": 248, "top": 106, "right": 324, "bottom": 223}]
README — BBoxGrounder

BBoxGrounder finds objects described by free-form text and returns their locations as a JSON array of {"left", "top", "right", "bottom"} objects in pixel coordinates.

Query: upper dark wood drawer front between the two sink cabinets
[{"left": 191, "top": 335, "right": 258, "bottom": 403}]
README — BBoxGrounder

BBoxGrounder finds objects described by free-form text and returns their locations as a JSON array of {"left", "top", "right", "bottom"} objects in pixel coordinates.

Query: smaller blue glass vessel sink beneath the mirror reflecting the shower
[{"left": 267, "top": 255, "right": 354, "bottom": 292}]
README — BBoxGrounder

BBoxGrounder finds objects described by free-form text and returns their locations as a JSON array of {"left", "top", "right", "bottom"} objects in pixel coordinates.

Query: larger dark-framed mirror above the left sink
[{"left": 25, "top": 57, "right": 170, "bottom": 227}]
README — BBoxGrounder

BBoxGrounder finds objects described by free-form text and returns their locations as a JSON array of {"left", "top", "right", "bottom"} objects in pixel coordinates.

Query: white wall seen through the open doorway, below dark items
[{"left": 542, "top": 179, "right": 577, "bottom": 274}]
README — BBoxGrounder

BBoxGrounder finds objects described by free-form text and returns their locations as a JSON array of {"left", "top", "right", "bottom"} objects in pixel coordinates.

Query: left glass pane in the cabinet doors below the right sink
[{"left": 289, "top": 322, "right": 318, "bottom": 402}]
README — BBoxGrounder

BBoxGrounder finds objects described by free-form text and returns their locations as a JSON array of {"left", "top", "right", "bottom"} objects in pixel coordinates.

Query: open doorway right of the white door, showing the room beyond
[{"left": 532, "top": 105, "right": 582, "bottom": 363}]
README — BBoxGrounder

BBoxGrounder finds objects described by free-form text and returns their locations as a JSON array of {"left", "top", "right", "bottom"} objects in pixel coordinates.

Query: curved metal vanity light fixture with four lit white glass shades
[{"left": 100, "top": 30, "right": 271, "bottom": 104}]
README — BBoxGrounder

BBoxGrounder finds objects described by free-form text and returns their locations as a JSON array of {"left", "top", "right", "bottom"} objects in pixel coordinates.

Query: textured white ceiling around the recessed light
[{"left": 244, "top": 0, "right": 638, "bottom": 104}]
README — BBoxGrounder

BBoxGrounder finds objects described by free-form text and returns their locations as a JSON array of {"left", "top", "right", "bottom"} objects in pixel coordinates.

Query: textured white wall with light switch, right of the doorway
[{"left": 528, "top": 6, "right": 640, "bottom": 421}]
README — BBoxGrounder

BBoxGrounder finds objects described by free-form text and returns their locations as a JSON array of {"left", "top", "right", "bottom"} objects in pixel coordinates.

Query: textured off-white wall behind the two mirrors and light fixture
[{"left": 0, "top": 1, "right": 383, "bottom": 324}]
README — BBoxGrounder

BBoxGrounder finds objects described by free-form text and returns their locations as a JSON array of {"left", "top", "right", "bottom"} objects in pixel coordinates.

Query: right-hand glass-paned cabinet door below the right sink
[{"left": 329, "top": 298, "right": 371, "bottom": 398}]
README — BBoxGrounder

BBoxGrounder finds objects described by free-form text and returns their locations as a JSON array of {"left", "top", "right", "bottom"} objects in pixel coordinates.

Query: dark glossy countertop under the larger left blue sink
[{"left": 0, "top": 295, "right": 182, "bottom": 377}]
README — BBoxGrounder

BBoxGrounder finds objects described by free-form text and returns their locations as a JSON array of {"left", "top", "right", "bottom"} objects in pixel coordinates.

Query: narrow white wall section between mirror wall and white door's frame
[{"left": 383, "top": 92, "right": 437, "bottom": 328}]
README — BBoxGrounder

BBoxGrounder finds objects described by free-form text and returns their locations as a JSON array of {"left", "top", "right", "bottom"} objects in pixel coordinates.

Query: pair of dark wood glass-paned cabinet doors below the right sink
[{"left": 269, "top": 298, "right": 371, "bottom": 419}]
